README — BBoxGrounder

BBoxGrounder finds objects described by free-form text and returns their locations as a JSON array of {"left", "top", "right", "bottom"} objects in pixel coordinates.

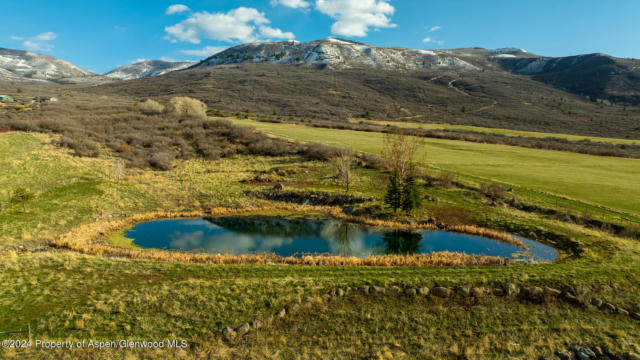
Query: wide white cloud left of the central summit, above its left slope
[{"left": 165, "top": 7, "right": 293, "bottom": 44}]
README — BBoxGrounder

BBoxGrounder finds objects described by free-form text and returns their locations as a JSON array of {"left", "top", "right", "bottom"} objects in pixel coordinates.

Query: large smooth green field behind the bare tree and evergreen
[{"left": 228, "top": 119, "right": 640, "bottom": 217}]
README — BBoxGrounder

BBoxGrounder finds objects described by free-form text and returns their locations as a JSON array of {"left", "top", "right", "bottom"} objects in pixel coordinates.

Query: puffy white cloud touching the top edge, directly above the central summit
[{"left": 316, "top": 0, "right": 397, "bottom": 37}]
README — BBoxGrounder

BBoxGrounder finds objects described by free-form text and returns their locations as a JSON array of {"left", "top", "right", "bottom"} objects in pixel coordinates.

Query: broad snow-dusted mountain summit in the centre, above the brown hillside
[{"left": 195, "top": 38, "right": 479, "bottom": 71}]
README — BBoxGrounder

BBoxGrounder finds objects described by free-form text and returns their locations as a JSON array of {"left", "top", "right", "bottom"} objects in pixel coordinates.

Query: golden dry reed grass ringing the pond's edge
[{"left": 53, "top": 204, "right": 526, "bottom": 267}]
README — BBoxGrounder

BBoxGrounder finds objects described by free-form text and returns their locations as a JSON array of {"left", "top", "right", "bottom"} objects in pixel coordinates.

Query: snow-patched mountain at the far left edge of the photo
[{"left": 0, "top": 48, "right": 94, "bottom": 81}]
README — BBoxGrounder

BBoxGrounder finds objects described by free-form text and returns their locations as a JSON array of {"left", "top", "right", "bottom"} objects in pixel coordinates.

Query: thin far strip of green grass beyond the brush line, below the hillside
[{"left": 360, "top": 119, "right": 640, "bottom": 145}]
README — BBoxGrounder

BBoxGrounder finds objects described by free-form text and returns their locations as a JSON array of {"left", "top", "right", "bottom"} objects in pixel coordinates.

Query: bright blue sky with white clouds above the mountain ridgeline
[{"left": 0, "top": 0, "right": 640, "bottom": 73}]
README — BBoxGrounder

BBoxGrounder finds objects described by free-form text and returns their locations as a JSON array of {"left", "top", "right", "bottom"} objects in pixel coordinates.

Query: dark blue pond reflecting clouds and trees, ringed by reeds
[{"left": 125, "top": 216, "right": 558, "bottom": 262}]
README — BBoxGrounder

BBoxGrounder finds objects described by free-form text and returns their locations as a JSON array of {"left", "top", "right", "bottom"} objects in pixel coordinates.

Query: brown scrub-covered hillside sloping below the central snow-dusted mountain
[{"left": 86, "top": 63, "right": 640, "bottom": 139}]
